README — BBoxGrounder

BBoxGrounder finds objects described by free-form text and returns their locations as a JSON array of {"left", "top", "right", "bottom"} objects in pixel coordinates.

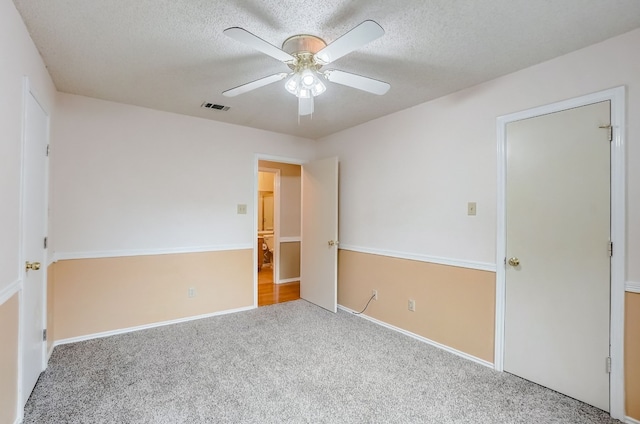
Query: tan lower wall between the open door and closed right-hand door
[{"left": 338, "top": 250, "right": 496, "bottom": 363}]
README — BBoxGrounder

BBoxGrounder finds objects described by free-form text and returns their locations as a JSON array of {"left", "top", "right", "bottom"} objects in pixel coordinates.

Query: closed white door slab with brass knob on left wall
[{"left": 21, "top": 88, "right": 49, "bottom": 405}]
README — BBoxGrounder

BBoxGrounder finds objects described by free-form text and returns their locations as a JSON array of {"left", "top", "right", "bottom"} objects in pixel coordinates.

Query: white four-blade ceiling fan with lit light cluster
[{"left": 222, "top": 20, "right": 391, "bottom": 116}]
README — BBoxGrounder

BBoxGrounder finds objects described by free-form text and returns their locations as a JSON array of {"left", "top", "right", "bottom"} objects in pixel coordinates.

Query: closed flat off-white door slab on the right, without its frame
[{"left": 504, "top": 101, "right": 610, "bottom": 411}]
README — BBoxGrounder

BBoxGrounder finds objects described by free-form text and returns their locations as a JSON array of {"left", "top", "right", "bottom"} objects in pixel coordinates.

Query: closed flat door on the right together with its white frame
[{"left": 495, "top": 88, "right": 625, "bottom": 418}]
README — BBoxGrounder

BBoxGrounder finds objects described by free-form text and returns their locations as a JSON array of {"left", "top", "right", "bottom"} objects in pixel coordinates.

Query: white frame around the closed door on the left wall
[{"left": 17, "top": 76, "right": 51, "bottom": 410}]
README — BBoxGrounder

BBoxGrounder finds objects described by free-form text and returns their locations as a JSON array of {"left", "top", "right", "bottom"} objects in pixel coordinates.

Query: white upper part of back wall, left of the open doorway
[{"left": 51, "top": 93, "right": 315, "bottom": 257}]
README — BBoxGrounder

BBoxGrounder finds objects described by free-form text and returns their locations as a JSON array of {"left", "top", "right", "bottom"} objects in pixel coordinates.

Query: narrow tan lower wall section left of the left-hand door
[{"left": 0, "top": 293, "right": 20, "bottom": 423}]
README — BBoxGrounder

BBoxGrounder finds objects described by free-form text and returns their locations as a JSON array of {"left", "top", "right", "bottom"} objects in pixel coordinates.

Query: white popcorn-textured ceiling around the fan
[{"left": 14, "top": 0, "right": 640, "bottom": 139}]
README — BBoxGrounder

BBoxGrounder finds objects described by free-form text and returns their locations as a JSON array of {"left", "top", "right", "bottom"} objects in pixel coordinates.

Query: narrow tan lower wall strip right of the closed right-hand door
[{"left": 624, "top": 292, "right": 640, "bottom": 420}]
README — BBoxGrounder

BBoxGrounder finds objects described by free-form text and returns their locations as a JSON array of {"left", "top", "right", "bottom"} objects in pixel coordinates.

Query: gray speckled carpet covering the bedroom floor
[{"left": 24, "top": 300, "right": 619, "bottom": 424}]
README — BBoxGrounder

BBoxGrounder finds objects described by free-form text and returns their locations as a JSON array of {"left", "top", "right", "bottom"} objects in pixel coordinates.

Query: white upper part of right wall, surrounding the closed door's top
[{"left": 318, "top": 30, "right": 640, "bottom": 281}]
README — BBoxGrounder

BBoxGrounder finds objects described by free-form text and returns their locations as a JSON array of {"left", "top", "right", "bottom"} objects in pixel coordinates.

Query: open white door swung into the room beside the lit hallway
[{"left": 300, "top": 157, "right": 338, "bottom": 312}]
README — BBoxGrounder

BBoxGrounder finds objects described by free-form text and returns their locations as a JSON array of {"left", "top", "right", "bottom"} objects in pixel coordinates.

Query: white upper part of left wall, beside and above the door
[{"left": 0, "top": 0, "right": 55, "bottom": 291}]
